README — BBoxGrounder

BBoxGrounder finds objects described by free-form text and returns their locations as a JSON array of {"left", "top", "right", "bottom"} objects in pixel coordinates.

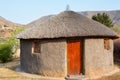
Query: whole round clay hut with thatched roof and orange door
[{"left": 17, "top": 11, "right": 118, "bottom": 77}]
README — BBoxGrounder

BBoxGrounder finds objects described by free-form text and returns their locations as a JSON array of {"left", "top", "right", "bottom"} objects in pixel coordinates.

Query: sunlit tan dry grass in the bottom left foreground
[{"left": 0, "top": 68, "right": 63, "bottom": 80}]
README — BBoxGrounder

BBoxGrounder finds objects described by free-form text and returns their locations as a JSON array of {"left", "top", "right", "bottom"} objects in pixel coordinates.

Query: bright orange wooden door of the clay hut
[{"left": 67, "top": 41, "right": 82, "bottom": 75}]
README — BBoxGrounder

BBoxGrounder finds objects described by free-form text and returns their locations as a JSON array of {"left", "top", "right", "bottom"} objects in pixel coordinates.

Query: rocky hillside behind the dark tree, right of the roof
[{"left": 79, "top": 10, "right": 120, "bottom": 26}]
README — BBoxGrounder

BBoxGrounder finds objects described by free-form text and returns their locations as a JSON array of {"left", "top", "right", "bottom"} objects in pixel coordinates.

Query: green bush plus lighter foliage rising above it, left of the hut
[{"left": 0, "top": 27, "right": 25, "bottom": 63}]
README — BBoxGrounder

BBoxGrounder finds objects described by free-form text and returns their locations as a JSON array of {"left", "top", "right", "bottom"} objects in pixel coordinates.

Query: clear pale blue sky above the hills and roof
[{"left": 0, "top": 0, "right": 120, "bottom": 24}]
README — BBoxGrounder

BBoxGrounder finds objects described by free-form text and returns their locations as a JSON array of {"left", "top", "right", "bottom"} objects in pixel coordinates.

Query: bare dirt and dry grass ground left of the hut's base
[{"left": 0, "top": 58, "right": 64, "bottom": 80}]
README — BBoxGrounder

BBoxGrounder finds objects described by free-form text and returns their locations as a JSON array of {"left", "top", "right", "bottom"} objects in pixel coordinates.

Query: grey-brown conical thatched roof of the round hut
[{"left": 17, "top": 11, "right": 118, "bottom": 39}]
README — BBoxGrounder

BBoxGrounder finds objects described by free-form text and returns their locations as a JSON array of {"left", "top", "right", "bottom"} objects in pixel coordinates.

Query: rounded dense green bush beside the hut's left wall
[{"left": 0, "top": 37, "right": 18, "bottom": 63}]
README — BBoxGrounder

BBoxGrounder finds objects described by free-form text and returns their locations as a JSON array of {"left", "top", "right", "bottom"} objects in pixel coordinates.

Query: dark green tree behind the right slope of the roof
[{"left": 92, "top": 13, "right": 114, "bottom": 28}]
